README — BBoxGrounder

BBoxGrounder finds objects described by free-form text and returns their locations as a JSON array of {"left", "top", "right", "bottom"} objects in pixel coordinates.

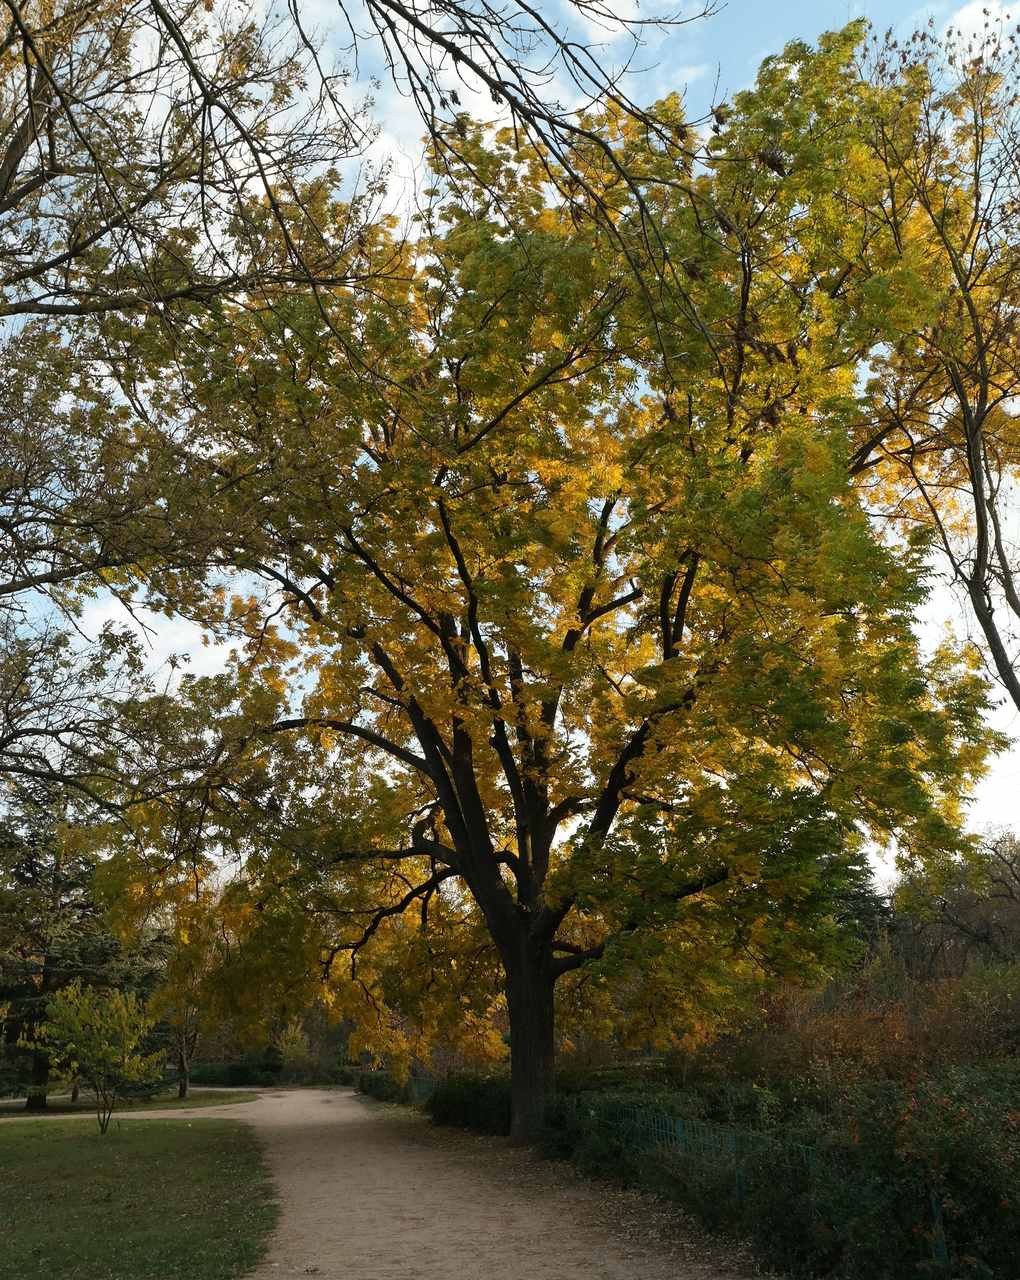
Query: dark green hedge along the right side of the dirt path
[{"left": 543, "top": 1064, "right": 1020, "bottom": 1280}]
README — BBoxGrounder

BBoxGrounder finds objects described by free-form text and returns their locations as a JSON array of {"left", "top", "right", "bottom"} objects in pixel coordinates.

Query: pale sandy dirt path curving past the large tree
[{"left": 133, "top": 1089, "right": 754, "bottom": 1280}]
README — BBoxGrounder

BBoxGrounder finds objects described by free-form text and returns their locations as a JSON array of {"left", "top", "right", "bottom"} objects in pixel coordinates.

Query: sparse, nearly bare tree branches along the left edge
[{"left": 0, "top": 0, "right": 373, "bottom": 797}]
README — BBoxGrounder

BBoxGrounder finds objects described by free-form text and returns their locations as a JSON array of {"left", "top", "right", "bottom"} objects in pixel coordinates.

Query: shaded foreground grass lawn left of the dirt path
[{"left": 0, "top": 1119, "right": 276, "bottom": 1280}]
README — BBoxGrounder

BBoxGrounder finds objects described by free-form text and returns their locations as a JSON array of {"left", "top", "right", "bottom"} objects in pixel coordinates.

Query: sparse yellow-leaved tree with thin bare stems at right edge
[{"left": 824, "top": 19, "right": 1020, "bottom": 708}]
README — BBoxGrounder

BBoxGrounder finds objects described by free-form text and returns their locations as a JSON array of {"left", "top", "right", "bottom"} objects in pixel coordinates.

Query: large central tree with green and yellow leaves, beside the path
[{"left": 97, "top": 36, "right": 1003, "bottom": 1137}]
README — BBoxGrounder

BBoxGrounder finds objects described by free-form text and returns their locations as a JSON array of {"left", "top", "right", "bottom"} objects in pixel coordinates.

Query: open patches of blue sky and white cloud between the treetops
[{"left": 81, "top": 0, "right": 1020, "bottom": 855}]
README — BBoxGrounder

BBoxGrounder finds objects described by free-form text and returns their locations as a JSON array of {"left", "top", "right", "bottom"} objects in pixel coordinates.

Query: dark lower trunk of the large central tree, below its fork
[{"left": 507, "top": 938, "right": 555, "bottom": 1143}]
